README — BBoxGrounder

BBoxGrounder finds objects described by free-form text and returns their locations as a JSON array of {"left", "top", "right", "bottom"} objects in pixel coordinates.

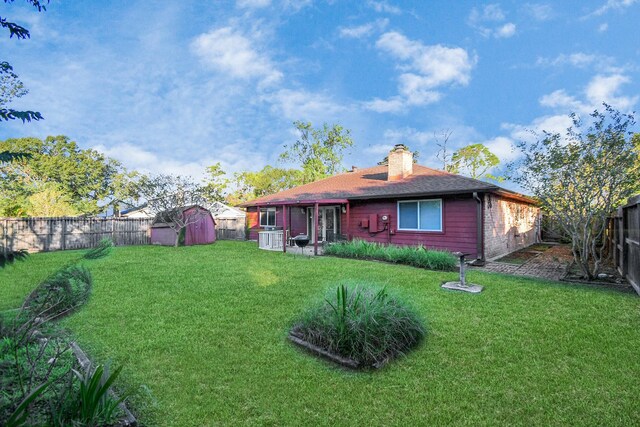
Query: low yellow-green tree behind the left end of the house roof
[{"left": 228, "top": 165, "right": 303, "bottom": 204}]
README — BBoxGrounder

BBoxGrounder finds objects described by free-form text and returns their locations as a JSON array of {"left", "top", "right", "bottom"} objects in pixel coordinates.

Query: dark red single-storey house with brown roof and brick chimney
[{"left": 240, "top": 144, "right": 540, "bottom": 262}]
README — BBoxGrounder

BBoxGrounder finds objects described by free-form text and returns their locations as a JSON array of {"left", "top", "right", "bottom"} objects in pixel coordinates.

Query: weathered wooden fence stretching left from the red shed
[{"left": 0, "top": 217, "right": 153, "bottom": 253}]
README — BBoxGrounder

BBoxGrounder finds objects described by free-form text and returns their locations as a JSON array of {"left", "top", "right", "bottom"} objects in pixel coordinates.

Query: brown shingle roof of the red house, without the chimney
[{"left": 240, "top": 165, "right": 532, "bottom": 207}]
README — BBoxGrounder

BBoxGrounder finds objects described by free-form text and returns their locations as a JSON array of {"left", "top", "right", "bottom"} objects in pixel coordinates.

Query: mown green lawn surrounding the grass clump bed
[{"left": 0, "top": 242, "right": 640, "bottom": 426}]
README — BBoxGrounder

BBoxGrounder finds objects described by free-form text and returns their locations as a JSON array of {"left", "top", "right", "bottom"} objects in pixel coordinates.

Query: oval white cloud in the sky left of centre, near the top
[{"left": 191, "top": 27, "right": 282, "bottom": 85}]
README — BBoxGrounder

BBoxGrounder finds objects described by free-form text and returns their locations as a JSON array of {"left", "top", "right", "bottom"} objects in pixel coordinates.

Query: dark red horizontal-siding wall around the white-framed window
[{"left": 342, "top": 196, "right": 478, "bottom": 258}]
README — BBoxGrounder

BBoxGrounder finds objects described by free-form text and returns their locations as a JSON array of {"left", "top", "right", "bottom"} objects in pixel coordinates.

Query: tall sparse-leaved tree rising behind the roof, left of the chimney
[{"left": 280, "top": 121, "right": 353, "bottom": 184}]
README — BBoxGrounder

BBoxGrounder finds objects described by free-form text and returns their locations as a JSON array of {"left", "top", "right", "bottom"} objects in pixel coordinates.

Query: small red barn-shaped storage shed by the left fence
[{"left": 151, "top": 205, "right": 216, "bottom": 246}]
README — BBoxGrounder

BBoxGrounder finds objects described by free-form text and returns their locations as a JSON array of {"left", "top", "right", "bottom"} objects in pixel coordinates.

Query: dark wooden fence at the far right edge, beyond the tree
[{"left": 613, "top": 195, "right": 640, "bottom": 294}]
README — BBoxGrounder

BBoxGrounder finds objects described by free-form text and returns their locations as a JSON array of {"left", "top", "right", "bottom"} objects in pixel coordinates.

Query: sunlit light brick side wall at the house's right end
[{"left": 484, "top": 194, "right": 540, "bottom": 259}]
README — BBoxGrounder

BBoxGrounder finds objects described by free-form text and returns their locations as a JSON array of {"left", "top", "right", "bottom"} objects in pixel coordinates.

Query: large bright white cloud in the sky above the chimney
[{"left": 364, "top": 31, "right": 476, "bottom": 112}]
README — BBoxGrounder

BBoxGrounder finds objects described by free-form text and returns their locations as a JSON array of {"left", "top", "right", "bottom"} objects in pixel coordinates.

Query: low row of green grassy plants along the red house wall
[{"left": 324, "top": 239, "right": 457, "bottom": 271}]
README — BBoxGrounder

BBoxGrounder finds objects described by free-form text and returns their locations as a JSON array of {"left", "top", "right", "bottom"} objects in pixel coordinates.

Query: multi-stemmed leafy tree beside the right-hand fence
[{"left": 510, "top": 104, "right": 640, "bottom": 280}]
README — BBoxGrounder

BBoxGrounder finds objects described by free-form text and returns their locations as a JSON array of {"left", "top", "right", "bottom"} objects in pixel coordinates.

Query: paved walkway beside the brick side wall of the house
[{"left": 471, "top": 245, "right": 573, "bottom": 280}]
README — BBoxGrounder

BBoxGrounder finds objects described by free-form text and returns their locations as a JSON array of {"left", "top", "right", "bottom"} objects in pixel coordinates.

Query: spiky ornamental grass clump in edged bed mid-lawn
[{"left": 291, "top": 285, "right": 426, "bottom": 367}]
